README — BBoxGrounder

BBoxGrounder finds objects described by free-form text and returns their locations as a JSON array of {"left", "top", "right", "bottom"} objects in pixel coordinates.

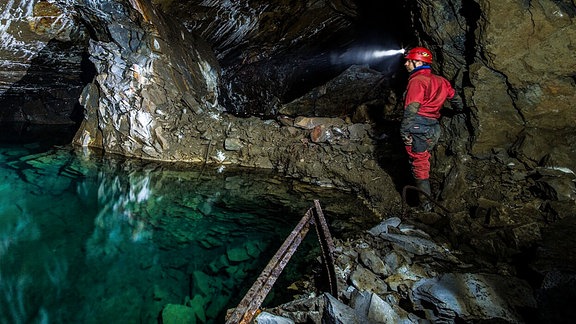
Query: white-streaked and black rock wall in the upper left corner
[{"left": 0, "top": 1, "right": 91, "bottom": 124}]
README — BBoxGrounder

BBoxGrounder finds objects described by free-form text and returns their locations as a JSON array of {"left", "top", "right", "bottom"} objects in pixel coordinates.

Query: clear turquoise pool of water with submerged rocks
[{"left": 0, "top": 132, "right": 372, "bottom": 323}]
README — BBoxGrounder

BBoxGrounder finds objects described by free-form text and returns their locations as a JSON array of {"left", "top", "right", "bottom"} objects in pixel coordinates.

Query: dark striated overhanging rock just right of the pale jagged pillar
[{"left": 162, "top": 0, "right": 357, "bottom": 117}]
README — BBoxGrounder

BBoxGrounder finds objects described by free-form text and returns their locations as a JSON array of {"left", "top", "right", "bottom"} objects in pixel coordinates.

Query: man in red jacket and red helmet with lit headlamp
[{"left": 400, "top": 47, "right": 463, "bottom": 211}]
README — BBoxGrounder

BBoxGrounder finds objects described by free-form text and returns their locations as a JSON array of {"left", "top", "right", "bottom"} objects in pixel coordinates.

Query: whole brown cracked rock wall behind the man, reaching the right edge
[{"left": 417, "top": 0, "right": 576, "bottom": 170}]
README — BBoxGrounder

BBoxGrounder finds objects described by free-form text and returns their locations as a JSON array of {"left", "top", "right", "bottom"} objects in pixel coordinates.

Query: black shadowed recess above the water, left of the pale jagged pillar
[{"left": 0, "top": 40, "right": 96, "bottom": 143}]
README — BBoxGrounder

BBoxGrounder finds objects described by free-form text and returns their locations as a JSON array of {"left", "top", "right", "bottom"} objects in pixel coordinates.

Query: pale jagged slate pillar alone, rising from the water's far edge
[{"left": 66, "top": 1, "right": 221, "bottom": 160}]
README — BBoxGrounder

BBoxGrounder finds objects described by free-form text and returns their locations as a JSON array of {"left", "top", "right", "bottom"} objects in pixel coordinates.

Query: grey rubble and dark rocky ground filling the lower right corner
[{"left": 251, "top": 155, "right": 576, "bottom": 323}]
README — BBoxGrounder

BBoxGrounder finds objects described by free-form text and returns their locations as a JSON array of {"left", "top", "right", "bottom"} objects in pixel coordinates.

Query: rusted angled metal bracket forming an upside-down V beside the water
[{"left": 226, "top": 200, "right": 338, "bottom": 324}]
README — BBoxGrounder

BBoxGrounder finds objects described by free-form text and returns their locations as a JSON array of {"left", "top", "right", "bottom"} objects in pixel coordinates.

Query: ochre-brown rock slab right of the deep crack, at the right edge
[{"left": 472, "top": 0, "right": 576, "bottom": 170}]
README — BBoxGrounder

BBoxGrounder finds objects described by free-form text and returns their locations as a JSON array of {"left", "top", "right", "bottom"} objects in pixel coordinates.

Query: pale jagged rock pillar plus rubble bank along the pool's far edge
[{"left": 58, "top": 1, "right": 399, "bottom": 212}]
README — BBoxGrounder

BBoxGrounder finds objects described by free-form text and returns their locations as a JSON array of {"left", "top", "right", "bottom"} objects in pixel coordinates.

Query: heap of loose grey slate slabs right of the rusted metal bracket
[{"left": 258, "top": 217, "right": 536, "bottom": 323}]
